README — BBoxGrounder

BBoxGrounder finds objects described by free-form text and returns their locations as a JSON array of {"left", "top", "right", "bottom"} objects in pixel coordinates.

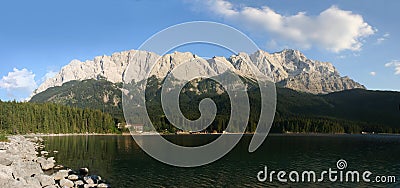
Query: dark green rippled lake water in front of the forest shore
[{"left": 44, "top": 134, "right": 400, "bottom": 187}]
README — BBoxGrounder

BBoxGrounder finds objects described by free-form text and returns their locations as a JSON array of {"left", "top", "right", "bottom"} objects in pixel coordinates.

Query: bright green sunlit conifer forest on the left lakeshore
[{"left": 0, "top": 101, "right": 118, "bottom": 134}]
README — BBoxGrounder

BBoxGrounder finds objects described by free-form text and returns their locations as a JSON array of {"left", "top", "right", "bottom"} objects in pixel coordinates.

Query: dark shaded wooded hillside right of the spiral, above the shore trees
[{"left": 275, "top": 88, "right": 400, "bottom": 133}]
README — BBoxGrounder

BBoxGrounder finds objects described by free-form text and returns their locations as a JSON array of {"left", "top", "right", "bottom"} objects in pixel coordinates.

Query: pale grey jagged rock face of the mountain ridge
[{"left": 33, "top": 50, "right": 365, "bottom": 95}]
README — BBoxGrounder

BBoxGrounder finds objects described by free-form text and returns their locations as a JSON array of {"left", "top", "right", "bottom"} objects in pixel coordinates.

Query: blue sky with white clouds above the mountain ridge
[{"left": 0, "top": 0, "right": 400, "bottom": 100}]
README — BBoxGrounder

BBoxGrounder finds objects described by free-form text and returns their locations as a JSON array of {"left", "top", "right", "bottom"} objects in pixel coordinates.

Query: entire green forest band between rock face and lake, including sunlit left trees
[{"left": 7, "top": 78, "right": 400, "bottom": 134}]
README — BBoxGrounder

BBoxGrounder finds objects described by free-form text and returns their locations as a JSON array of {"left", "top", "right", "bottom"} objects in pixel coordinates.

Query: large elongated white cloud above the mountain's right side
[{"left": 196, "top": 0, "right": 376, "bottom": 52}]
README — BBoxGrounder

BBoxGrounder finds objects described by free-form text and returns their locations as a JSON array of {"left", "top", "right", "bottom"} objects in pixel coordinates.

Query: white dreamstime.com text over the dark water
[{"left": 257, "top": 159, "right": 396, "bottom": 183}]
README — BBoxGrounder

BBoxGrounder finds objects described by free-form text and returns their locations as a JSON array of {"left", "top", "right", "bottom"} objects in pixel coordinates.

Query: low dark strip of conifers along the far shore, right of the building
[{"left": 147, "top": 115, "right": 400, "bottom": 134}]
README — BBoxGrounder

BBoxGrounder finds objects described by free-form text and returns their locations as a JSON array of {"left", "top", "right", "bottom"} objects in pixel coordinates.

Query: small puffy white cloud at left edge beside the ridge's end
[{"left": 0, "top": 68, "right": 37, "bottom": 97}]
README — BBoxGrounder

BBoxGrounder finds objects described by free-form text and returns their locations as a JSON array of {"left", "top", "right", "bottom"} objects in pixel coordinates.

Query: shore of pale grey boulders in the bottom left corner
[{"left": 0, "top": 136, "right": 110, "bottom": 188}]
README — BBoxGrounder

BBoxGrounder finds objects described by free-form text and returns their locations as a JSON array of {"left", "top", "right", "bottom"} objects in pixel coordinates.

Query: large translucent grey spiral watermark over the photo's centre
[{"left": 122, "top": 21, "right": 276, "bottom": 167}]
